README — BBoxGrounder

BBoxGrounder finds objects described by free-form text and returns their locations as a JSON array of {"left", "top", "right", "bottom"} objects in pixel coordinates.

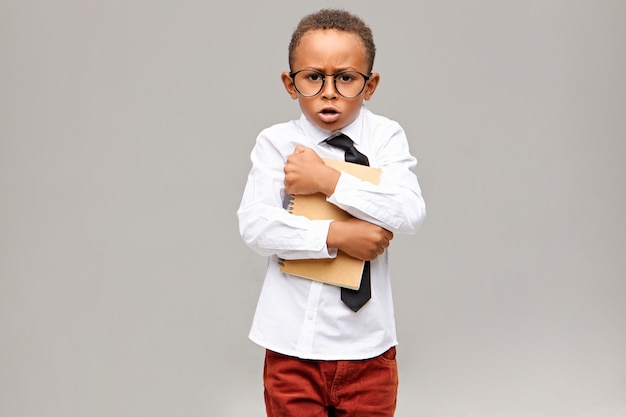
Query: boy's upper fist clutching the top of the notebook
[{"left": 284, "top": 145, "right": 340, "bottom": 195}]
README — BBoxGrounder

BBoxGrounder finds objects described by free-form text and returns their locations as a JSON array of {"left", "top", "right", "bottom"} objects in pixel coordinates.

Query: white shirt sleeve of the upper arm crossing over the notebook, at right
[{"left": 328, "top": 125, "right": 426, "bottom": 234}]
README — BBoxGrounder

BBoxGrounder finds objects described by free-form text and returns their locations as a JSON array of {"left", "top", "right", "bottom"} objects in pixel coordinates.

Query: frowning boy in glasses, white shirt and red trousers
[{"left": 238, "top": 10, "right": 425, "bottom": 417}]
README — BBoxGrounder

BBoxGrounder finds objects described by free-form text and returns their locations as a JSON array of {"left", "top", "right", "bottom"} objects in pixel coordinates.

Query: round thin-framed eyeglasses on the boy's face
[{"left": 289, "top": 69, "right": 370, "bottom": 98}]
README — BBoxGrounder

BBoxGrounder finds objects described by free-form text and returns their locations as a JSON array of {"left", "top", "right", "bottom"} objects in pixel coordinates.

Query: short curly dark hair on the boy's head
[{"left": 289, "top": 9, "right": 376, "bottom": 72}]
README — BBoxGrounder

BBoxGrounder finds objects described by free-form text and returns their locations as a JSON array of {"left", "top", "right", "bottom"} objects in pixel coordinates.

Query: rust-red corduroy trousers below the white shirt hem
[{"left": 263, "top": 347, "right": 398, "bottom": 417}]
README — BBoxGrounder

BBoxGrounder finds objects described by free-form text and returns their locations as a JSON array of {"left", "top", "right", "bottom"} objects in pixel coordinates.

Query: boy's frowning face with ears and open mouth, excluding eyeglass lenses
[{"left": 282, "top": 30, "right": 380, "bottom": 131}]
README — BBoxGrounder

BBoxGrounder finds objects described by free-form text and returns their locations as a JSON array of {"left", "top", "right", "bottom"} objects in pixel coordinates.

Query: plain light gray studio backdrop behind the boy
[{"left": 0, "top": 0, "right": 626, "bottom": 417}]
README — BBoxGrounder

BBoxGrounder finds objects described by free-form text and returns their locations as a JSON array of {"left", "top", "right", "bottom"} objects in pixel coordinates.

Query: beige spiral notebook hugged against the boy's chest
[{"left": 280, "top": 159, "right": 381, "bottom": 290}]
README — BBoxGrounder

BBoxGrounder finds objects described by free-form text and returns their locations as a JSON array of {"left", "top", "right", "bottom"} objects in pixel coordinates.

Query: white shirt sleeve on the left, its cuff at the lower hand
[{"left": 237, "top": 132, "right": 337, "bottom": 259}]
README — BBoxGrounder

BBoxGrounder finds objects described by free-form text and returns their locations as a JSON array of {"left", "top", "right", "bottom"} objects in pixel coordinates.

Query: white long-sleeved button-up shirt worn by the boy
[{"left": 237, "top": 107, "right": 426, "bottom": 360}]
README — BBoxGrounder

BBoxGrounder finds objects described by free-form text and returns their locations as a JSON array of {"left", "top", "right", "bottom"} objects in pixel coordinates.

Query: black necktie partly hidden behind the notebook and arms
[{"left": 326, "top": 133, "right": 372, "bottom": 312}]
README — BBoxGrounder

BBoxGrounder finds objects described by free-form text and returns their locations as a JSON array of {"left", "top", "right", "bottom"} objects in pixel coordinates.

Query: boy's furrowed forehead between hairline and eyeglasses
[{"left": 294, "top": 29, "right": 367, "bottom": 71}]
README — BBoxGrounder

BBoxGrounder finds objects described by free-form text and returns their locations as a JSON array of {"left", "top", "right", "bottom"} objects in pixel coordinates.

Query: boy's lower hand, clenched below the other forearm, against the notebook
[{"left": 326, "top": 218, "right": 393, "bottom": 261}]
